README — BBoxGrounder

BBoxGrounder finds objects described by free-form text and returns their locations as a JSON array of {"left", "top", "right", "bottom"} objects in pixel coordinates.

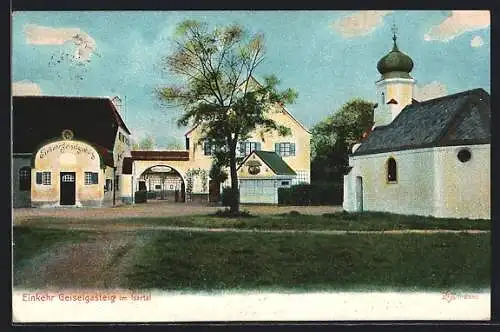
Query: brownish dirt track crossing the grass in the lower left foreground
[{"left": 14, "top": 232, "right": 142, "bottom": 289}]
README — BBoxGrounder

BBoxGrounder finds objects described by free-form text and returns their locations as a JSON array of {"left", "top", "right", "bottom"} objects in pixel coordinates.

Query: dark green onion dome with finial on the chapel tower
[{"left": 377, "top": 34, "right": 413, "bottom": 78}]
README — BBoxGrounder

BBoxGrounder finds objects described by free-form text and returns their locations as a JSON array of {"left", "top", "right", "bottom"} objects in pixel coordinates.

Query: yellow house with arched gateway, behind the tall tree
[{"left": 131, "top": 93, "right": 311, "bottom": 203}]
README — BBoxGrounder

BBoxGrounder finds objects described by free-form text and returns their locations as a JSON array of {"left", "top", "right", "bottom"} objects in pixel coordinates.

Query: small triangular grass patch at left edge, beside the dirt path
[{"left": 12, "top": 226, "right": 89, "bottom": 265}]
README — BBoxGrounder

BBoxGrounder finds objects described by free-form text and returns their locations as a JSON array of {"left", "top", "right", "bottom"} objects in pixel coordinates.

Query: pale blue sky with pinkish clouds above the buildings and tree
[{"left": 11, "top": 11, "right": 491, "bottom": 148}]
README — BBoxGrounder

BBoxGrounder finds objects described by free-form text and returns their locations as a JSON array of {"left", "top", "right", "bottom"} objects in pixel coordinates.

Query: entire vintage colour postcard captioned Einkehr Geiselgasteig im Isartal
[{"left": 11, "top": 10, "right": 491, "bottom": 323}]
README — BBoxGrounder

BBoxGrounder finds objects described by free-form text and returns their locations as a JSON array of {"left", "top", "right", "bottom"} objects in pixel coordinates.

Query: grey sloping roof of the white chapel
[{"left": 353, "top": 88, "right": 491, "bottom": 156}]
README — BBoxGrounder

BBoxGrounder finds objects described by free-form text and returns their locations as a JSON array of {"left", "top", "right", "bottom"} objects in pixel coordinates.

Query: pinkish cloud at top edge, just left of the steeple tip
[{"left": 332, "top": 10, "right": 392, "bottom": 38}]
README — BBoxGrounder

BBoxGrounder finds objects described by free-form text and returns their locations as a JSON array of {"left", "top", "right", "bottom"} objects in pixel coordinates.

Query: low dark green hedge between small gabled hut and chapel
[{"left": 278, "top": 183, "right": 344, "bottom": 205}]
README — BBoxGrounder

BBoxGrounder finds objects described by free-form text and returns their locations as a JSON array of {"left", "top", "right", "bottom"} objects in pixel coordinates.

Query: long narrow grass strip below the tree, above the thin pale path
[{"left": 18, "top": 212, "right": 491, "bottom": 231}]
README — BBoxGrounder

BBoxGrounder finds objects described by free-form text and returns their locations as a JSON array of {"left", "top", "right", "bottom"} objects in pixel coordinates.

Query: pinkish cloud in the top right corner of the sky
[{"left": 424, "top": 10, "right": 490, "bottom": 42}]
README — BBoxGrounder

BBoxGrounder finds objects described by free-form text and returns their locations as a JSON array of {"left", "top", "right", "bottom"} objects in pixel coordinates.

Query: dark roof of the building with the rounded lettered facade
[{"left": 12, "top": 96, "right": 130, "bottom": 153}]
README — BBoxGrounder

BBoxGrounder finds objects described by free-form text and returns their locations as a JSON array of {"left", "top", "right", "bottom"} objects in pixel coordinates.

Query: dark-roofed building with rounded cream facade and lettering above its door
[{"left": 12, "top": 96, "right": 132, "bottom": 207}]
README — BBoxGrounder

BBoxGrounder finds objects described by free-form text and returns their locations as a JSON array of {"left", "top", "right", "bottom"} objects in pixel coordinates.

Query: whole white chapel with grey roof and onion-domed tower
[{"left": 343, "top": 31, "right": 491, "bottom": 219}]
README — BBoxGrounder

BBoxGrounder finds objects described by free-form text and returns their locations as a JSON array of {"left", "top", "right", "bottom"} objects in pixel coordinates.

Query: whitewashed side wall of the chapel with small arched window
[{"left": 343, "top": 144, "right": 490, "bottom": 219}]
